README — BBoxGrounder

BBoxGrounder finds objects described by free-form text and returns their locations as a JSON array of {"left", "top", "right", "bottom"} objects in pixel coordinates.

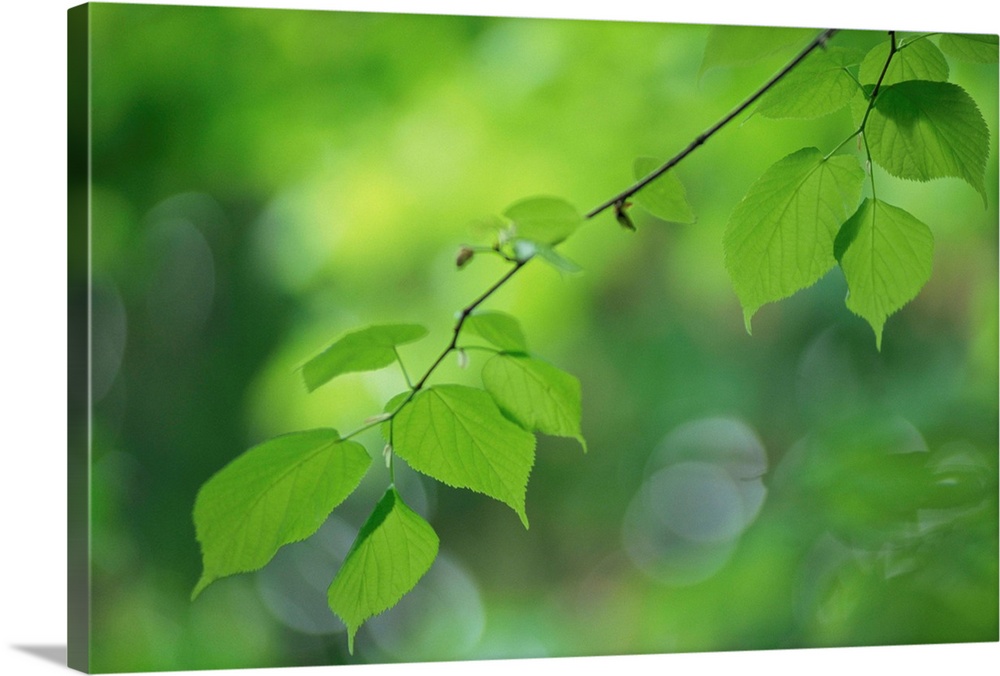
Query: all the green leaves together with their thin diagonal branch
[{"left": 192, "top": 28, "right": 997, "bottom": 652}]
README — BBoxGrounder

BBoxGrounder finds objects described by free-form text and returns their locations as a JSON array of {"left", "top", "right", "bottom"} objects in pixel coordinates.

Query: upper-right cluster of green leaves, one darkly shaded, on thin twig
[{"left": 715, "top": 29, "right": 997, "bottom": 347}]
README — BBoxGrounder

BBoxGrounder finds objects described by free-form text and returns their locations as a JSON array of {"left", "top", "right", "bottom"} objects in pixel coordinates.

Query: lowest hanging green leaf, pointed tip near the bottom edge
[{"left": 327, "top": 486, "right": 439, "bottom": 654}]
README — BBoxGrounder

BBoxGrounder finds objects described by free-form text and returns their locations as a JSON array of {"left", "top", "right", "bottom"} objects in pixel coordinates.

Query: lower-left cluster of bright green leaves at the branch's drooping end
[{"left": 192, "top": 197, "right": 586, "bottom": 652}]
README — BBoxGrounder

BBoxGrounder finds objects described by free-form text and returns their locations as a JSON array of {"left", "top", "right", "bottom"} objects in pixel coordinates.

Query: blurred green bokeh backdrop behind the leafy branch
[{"left": 80, "top": 4, "right": 998, "bottom": 671}]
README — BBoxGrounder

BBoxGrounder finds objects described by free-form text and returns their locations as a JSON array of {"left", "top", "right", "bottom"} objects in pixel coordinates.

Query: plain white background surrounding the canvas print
[{"left": 0, "top": 0, "right": 1000, "bottom": 676}]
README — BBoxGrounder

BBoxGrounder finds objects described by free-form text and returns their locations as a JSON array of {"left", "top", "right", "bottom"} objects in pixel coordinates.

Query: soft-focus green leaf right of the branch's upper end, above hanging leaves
[{"left": 757, "top": 47, "right": 859, "bottom": 119}]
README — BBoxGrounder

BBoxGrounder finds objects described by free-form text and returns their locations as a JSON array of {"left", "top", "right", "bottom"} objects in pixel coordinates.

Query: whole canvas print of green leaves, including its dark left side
[{"left": 68, "top": 3, "right": 998, "bottom": 673}]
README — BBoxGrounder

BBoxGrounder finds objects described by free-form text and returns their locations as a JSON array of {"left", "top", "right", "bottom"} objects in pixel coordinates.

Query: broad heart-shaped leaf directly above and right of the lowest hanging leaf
[{"left": 393, "top": 385, "right": 535, "bottom": 528}]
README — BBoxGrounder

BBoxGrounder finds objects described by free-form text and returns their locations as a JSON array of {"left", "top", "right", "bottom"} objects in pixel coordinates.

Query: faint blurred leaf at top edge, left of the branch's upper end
[{"left": 699, "top": 25, "right": 816, "bottom": 74}]
